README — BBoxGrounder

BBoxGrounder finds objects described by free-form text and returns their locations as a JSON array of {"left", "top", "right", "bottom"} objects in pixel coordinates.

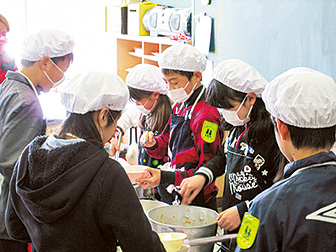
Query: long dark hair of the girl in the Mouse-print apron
[{"left": 206, "top": 79, "right": 287, "bottom": 181}]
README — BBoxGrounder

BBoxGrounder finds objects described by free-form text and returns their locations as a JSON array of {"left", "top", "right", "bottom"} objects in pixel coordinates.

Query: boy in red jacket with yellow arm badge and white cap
[{"left": 139, "top": 44, "right": 222, "bottom": 209}]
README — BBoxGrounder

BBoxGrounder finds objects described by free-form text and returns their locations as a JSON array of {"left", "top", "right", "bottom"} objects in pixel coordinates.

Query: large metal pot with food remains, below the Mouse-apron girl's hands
[{"left": 147, "top": 205, "right": 218, "bottom": 252}]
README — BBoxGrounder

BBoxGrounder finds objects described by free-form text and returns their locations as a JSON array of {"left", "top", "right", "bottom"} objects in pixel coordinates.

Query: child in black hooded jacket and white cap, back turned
[{"left": 6, "top": 72, "right": 165, "bottom": 252}]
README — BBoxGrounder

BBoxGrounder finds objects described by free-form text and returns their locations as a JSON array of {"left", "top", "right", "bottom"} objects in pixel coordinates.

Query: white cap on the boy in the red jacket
[{"left": 159, "top": 44, "right": 207, "bottom": 72}]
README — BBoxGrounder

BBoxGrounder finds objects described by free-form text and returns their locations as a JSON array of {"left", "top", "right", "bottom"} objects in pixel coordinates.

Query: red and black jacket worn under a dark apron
[{"left": 147, "top": 87, "right": 223, "bottom": 202}]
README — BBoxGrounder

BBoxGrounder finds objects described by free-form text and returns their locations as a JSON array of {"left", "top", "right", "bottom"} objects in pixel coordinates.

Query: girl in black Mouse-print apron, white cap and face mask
[{"left": 181, "top": 59, "right": 284, "bottom": 251}]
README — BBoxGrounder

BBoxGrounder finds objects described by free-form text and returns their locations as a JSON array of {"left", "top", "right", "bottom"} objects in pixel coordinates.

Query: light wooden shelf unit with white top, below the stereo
[{"left": 116, "top": 34, "right": 190, "bottom": 80}]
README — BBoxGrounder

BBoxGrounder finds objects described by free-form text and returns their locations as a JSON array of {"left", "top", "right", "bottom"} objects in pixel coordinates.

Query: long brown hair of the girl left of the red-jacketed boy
[{"left": 128, "top": 87, "right": 172, "bottom": 133}]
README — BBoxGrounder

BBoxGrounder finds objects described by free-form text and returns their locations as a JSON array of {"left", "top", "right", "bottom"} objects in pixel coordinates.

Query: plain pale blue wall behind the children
[{"left": 193, "top": 0, "right": 336, "bottom": 80}]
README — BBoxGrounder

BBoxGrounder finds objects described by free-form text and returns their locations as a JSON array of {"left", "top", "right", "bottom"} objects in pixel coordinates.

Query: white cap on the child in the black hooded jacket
[{"left": 60, "top": 72, "right": 129, "bottom": 114}]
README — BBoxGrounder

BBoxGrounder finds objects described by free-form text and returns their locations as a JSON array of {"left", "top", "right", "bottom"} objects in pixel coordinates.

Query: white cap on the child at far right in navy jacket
[{"left": 262, "top": 67, "right": 336, "bottom": 129}]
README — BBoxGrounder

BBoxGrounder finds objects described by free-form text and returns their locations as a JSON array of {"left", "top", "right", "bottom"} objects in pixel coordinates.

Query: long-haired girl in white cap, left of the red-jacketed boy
[{"left": 112, "top": 64, "right": 172, "bottom": 161}]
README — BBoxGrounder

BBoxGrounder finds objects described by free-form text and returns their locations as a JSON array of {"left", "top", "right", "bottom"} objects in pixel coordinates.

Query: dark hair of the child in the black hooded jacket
[{"left": 58, "top": 110, "right": 121, "bottom": 148}]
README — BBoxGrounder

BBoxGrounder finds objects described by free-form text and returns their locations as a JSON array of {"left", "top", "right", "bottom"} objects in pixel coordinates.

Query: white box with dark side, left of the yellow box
[{"left": 105, "top": 6, "right": 127, "bottom": 34}]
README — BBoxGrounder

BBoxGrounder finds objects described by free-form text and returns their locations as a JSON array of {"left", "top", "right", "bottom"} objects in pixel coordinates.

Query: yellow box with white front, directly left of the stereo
[{"left": 127, "top": 2, "right": 157, "bottom": 36}]
